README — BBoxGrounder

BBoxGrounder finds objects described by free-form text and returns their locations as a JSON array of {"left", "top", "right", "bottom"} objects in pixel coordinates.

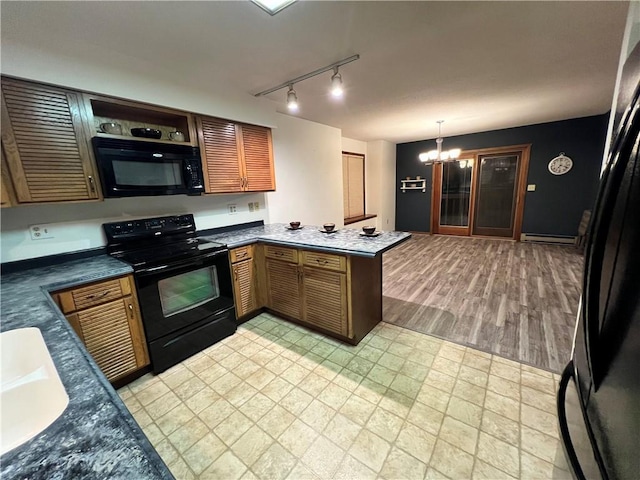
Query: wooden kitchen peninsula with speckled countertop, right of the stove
[{"left": 205, "top": 224, "right": 411, "bottom": 345}]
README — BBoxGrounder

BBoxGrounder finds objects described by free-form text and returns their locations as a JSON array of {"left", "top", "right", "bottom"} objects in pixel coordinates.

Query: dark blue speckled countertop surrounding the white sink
[{"left": 0, "top": 255, "right": 173, "bottom": 480}]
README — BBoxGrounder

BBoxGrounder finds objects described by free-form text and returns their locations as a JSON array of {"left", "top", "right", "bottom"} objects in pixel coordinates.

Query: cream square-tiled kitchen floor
[{"left": 119, "top": 314, "right": 571, "bottom": 480}]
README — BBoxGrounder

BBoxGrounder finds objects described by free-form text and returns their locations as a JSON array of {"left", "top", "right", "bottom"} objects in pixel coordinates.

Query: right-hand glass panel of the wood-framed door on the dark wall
[{"left": 472, "top": 153, "right": 520, "bottom": 237}]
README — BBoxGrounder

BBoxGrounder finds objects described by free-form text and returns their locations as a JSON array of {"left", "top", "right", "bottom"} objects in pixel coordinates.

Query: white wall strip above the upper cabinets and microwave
[{"left": 2, "top": 37, "right": 275, "bottom": 127}]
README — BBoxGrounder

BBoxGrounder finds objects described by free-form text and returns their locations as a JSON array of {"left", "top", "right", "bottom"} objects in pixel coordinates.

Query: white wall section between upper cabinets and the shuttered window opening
[{"left": 266, "top": 114, "right": 344, "bottom": 227}]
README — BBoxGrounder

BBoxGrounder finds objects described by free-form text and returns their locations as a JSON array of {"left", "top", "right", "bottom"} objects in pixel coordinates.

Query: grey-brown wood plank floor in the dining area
[{"left": 383, "top": 235, "right": 583, "bottom": 372}]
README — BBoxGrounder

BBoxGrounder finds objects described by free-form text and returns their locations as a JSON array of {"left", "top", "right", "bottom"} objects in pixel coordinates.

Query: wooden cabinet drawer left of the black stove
[{"left": 55, "top": 277, "right": 131, "bottom": 313}]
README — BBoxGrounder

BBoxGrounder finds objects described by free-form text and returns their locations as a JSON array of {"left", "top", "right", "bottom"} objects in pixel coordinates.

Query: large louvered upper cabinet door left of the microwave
[{"left": 2, "top": 78, "right": 99, "bottom": 203}]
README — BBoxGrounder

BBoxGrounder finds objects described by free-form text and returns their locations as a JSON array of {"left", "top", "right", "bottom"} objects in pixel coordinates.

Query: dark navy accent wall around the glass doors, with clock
[{"left": 396, "top": 113, "right": 609, "bottom": 236}]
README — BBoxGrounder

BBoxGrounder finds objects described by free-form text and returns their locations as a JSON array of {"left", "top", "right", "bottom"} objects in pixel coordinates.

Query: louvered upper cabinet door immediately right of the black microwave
[{"left": 196, "top": 116, "right": 244, "bottom": 193}]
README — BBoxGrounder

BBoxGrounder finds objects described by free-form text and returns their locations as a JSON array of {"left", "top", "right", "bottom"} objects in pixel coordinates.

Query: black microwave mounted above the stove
[{"left": 93, "top": 137, "right": 204, "bottom": 198}]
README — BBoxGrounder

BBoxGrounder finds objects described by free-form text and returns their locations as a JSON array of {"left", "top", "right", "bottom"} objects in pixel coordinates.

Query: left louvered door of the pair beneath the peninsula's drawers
[{"left": 266, "top": 259, "right": 301, "bottom": 318}]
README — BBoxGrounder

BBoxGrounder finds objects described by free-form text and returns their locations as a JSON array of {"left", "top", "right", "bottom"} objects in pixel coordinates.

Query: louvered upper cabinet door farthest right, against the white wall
[{"left": 241, "top": 125, "right": 276, "bottom": 192}]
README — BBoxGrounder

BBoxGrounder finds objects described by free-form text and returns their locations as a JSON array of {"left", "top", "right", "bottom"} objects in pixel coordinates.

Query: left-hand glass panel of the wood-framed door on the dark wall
[{"left": 433, "top": 156, "right": 474, "bottom": 235}]
